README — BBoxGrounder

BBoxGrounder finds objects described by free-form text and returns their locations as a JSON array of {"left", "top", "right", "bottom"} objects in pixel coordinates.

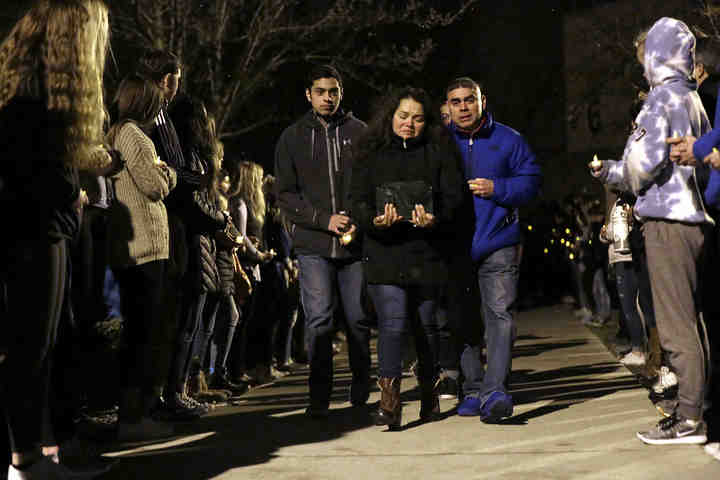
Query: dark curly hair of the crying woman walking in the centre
[{"left": 359, "top": 87, "right": 451, "bottom": 159}]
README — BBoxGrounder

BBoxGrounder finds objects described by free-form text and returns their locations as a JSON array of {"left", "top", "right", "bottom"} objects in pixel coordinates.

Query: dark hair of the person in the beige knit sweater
[{"left": 114, "top": 74, "right": 163, "bottom": 128}]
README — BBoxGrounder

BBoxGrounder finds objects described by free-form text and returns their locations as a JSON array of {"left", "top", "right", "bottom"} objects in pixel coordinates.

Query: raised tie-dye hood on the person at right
[{"left": 644, "top": 17, "right": 695, "bottom": 87}]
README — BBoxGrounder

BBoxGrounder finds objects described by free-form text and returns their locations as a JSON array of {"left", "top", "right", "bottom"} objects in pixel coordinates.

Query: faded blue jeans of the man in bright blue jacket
[{"left": 460, "top": 246, "right": 519, "bottom": 401}]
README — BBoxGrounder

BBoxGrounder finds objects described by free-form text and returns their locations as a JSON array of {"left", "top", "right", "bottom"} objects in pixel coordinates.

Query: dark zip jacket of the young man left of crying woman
[{"left": 275, "top": 111, "right": 366, "bottom": 258}]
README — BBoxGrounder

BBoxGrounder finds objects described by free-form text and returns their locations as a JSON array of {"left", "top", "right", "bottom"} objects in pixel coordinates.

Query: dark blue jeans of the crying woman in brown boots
[{"left": 368, "top": 285, "right": 438, "bottom": 383}]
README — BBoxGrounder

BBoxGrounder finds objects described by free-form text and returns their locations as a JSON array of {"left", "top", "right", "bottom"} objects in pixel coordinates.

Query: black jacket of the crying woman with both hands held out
[{"left": 352, "top": 138, "right": 463, "bottom": 286}]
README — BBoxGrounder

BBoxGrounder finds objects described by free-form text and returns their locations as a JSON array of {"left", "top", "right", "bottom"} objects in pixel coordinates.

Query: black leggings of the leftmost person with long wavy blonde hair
[{"left": 0, "top": 238, "right": 68, "bottom": 453}]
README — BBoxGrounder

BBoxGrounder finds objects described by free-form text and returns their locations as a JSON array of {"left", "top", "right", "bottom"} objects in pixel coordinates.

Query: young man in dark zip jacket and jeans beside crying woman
[{"left": 275, "top": 65, "right": 370, "bottom": 417}]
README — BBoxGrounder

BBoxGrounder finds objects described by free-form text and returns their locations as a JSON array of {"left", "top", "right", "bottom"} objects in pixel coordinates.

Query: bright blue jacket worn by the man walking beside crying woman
[{"left": 451, "top": 111, "right": 542, "bottom": 262}]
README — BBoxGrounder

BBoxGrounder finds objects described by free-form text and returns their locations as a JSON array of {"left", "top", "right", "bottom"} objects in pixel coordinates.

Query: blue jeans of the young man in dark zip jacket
[{"left": 298, "top": 255, "right": 370, "bottom": 407}]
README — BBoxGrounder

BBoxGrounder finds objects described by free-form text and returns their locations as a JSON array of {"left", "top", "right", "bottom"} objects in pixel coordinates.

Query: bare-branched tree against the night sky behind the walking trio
[{"left": 112, "top": 0, "right": 480, "bottom": 137}]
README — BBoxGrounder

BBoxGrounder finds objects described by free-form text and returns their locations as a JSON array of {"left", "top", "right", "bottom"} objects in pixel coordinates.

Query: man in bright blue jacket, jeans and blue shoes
[{"left": 446, "top": 77, "right": 541, "bottom": 423}]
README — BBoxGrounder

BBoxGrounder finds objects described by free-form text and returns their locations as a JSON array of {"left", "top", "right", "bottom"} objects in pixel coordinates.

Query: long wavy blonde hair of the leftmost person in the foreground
[{"left": 0, "top": 0, "right": 110, "bottom": 170}]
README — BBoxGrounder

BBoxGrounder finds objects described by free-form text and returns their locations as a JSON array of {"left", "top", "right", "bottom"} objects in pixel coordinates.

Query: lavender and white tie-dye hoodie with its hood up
[{"left": 597, "top": 17, "right": 712, "bottom": 223}]
